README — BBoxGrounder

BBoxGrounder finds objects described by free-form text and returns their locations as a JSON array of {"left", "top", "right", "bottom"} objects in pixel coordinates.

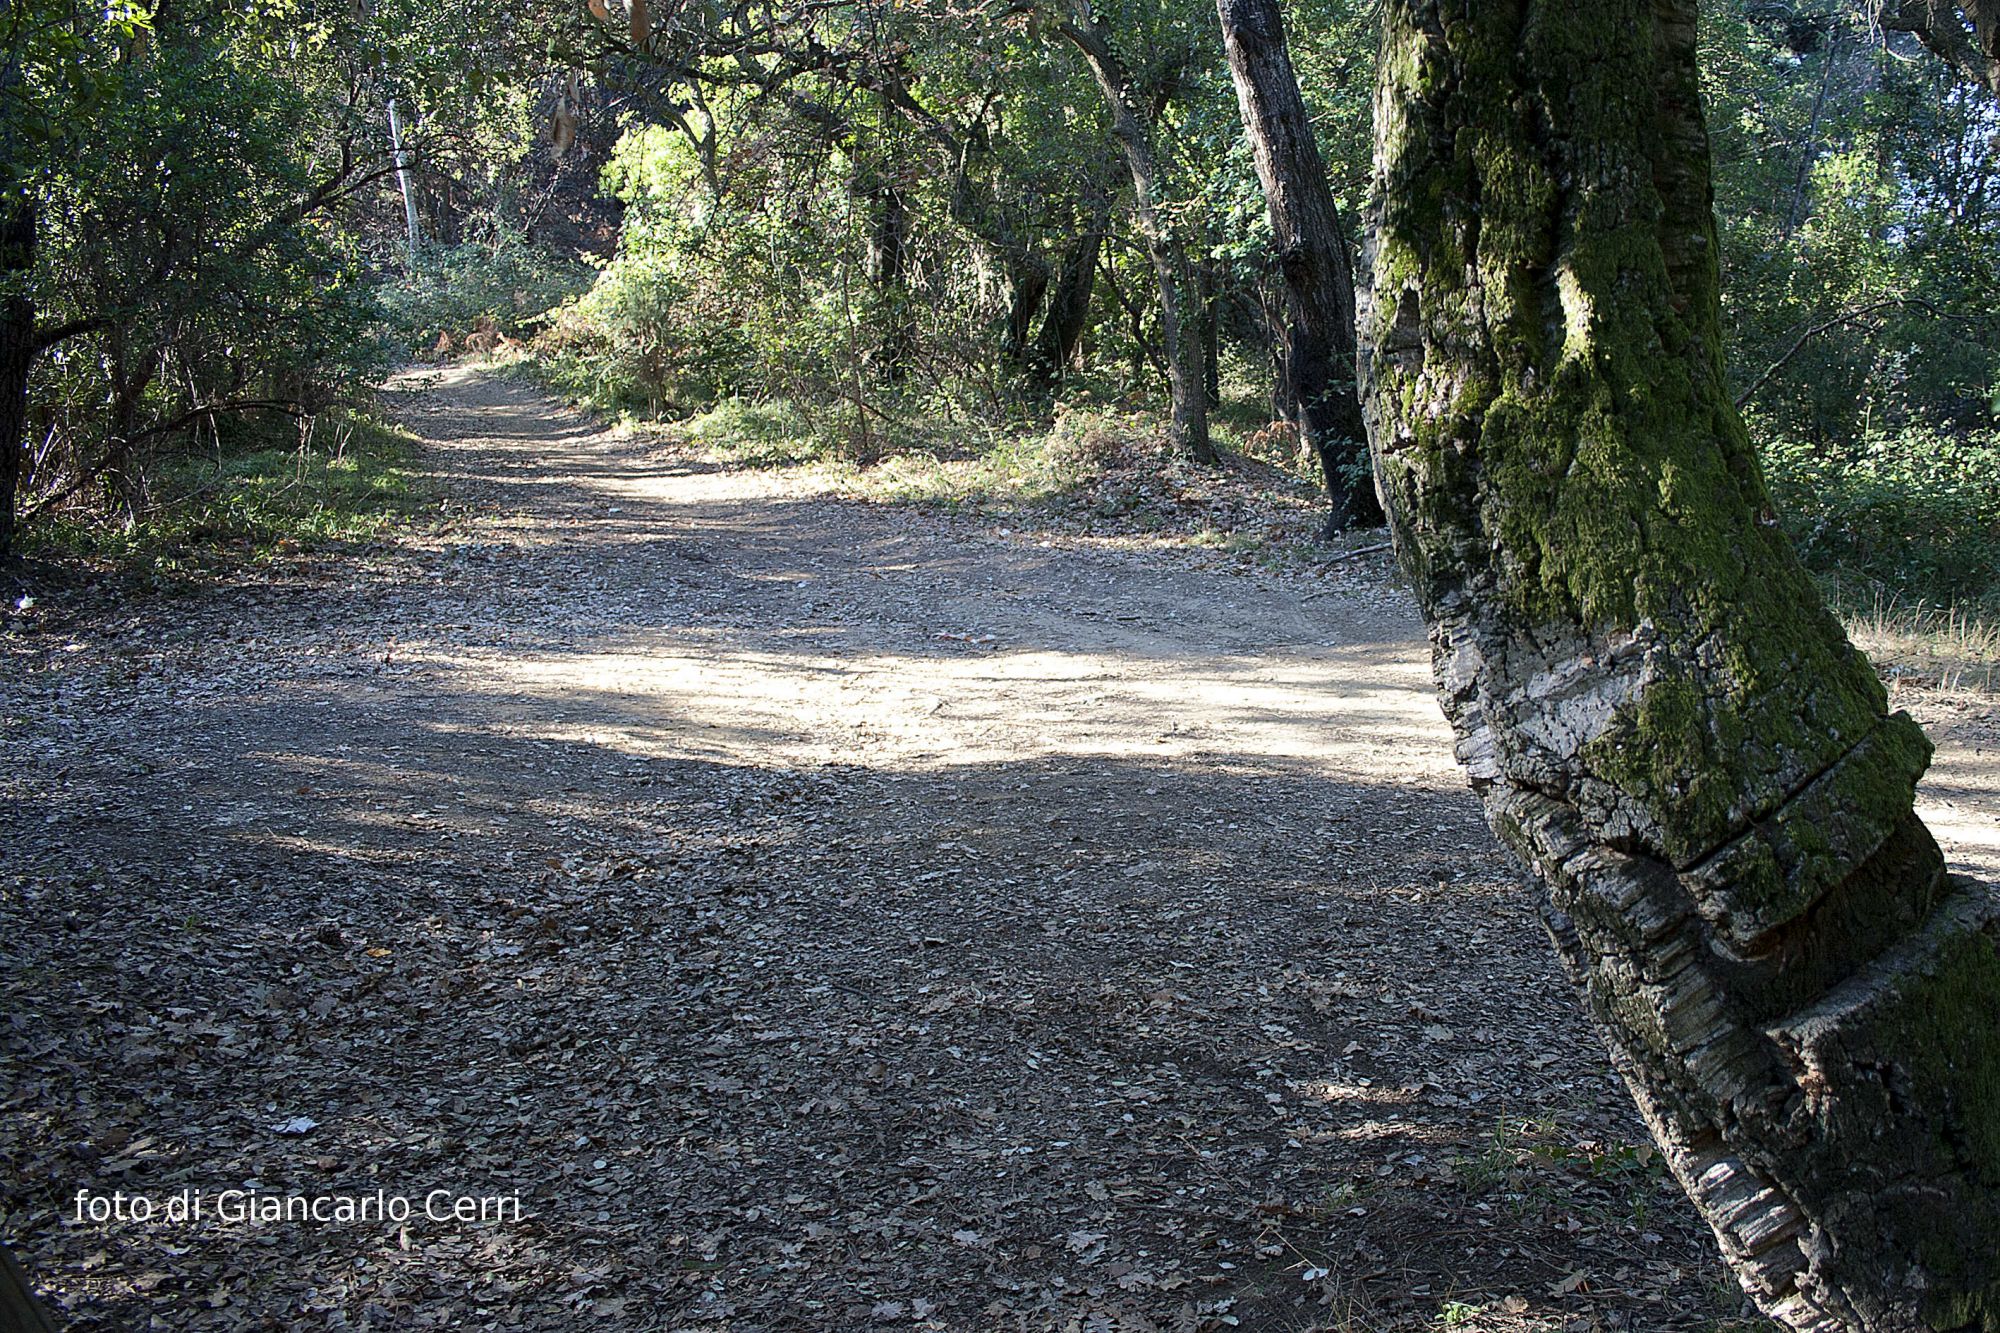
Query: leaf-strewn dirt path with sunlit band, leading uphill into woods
[{"left": 0, "top": 372, "right": 2000, "bottom": 1333}]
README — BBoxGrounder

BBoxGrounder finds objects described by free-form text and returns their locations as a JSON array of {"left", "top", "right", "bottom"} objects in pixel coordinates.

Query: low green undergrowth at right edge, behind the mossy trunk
[{"left": 1764, "top": 426, "right": 2000, "bottom": 606}]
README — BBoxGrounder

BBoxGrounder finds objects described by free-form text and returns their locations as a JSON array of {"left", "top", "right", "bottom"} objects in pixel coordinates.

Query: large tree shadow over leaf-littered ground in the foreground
[{"left": 4, "top": 701, "right": 1752, "bottom": 1329}]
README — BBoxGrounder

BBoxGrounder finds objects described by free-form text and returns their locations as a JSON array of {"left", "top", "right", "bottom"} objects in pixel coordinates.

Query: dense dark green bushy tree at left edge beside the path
[{"left": 14, "top": 8, "right": 390, "bottom": 516}]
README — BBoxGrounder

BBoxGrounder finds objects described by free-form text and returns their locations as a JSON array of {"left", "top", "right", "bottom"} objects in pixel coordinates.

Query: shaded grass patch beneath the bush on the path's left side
[{"left": 22, "top": 412, "right": 424, "bottom": 584}]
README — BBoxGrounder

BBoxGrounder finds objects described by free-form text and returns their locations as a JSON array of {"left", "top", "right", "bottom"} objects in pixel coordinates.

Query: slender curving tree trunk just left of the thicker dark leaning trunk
[{"left": 1062, "top": 0, "right": 1216, "bottom": 462}]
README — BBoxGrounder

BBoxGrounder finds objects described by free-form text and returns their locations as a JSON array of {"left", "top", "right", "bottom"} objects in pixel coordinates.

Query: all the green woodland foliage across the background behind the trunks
[{"left": 0, "top": 0, "right": 2000, "bottom": 628}]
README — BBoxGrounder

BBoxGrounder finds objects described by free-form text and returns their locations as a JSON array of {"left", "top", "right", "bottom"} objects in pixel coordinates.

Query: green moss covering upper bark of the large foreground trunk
[{"left": 1372, "top": 4, "right": 1922, "bottom": 915}]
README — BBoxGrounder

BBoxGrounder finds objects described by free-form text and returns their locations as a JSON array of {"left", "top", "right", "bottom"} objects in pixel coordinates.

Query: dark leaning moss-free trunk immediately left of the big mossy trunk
[{"left": 1216, "top": 0, "right": 1382, "bottom": 532}]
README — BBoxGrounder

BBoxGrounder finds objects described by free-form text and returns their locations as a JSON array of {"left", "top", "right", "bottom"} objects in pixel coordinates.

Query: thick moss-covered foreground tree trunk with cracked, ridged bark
[{"left": 1362, "top": 0, "right": 2000, "bottom": 1333}]
